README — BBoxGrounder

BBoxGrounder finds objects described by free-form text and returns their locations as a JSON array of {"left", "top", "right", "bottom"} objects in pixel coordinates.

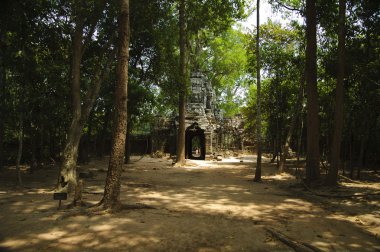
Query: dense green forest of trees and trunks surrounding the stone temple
[{"left": 0, "top": 0, "right": 380, "bottom": 207}]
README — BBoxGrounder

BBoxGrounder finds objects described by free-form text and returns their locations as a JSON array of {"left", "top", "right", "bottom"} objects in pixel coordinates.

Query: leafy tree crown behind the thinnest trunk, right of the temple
[{"left": 243, "top": 21, "right": 304, "bottom": 150}]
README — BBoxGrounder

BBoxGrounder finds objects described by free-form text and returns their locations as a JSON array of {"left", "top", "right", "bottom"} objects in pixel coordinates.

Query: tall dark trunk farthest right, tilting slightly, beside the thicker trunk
[{"left": 326, "top": 0, "right": 346, "bottom": 185}]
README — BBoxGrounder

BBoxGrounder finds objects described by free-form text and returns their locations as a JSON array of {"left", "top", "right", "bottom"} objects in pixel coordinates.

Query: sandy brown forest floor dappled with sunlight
[{"left": 0, "top": 156, "right": 380, "bottom": 252}]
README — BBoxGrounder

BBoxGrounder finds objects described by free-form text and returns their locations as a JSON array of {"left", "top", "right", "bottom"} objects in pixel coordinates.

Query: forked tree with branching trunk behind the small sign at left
[{"left": 58, "top": 1, "right": 113, "bottom": 203}]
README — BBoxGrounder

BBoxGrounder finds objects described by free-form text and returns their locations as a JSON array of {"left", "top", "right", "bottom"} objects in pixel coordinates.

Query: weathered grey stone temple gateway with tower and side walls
[{"left": 151, "top": 72, "right": 243, "bottom": 160}]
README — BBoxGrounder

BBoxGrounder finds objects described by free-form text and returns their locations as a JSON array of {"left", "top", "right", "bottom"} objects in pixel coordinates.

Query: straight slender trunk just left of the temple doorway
[{"left": 177, "top": 0, "right": 187, "bottom": 165}]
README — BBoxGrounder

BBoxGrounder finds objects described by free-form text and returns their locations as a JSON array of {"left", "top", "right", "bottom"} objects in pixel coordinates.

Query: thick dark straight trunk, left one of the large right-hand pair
[{"left": 306, "top": 0, "right": 320, "bottom": 182}]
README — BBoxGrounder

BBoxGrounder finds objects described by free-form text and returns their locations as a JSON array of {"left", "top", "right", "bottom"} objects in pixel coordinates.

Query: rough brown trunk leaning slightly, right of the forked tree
[{"left": 100, "top": 0, "right": 130, "bottom": 210}]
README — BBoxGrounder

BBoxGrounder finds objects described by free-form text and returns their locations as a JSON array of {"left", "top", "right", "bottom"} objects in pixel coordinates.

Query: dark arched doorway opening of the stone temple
[{"left": 185, "top": 123, "right": 206, "bottom": 160}]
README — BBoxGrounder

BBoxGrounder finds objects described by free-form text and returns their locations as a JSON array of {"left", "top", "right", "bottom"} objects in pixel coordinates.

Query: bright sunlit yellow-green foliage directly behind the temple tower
[{"left": 192, "top": 28, "right": 248, "bottom": 117}]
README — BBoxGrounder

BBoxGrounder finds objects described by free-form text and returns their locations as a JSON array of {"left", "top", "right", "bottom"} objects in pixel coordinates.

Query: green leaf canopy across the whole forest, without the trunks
[{"left": 0, "top": 0, "right": 380, "bottom": 169}]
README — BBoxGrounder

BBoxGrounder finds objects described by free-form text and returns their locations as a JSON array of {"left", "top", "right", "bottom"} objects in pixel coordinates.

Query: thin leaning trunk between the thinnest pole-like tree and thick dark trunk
[{"left": 279, "top": 75, "right": 305, "bottom": 172}]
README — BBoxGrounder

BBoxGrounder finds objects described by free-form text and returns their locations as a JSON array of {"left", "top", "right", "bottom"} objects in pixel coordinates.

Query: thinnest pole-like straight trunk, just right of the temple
[{"left": 254, "top": 0, "right": 262, "bottom": 181}]
